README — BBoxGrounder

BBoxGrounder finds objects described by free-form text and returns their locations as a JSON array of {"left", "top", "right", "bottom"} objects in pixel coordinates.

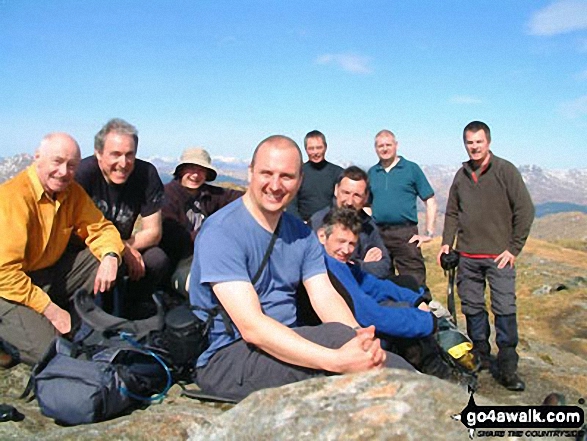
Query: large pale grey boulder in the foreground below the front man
[{"left": 189, "top": 369, "right": 525, "bottom": 441}]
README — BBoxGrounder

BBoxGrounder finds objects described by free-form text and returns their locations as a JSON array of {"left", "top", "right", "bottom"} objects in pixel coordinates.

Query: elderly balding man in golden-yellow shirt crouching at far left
[{"left": 0, "top": 133, "right": 124, "bottom": 364}]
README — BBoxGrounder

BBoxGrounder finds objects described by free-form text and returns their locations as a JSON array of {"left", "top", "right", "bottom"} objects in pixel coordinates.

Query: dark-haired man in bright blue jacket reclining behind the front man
[{"left": 318, "top": 207, "right": 458, "bottom": 379}]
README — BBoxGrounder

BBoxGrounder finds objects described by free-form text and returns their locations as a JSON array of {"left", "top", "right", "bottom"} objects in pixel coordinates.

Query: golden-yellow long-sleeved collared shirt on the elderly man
[{"left": 0, "top": 164, "right": 124, "bottom": 313}]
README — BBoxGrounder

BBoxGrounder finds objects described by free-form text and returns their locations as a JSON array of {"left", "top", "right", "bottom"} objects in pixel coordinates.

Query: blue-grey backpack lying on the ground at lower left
[{"left": 23, "top": 337, "right": 172, "bottom": 425}]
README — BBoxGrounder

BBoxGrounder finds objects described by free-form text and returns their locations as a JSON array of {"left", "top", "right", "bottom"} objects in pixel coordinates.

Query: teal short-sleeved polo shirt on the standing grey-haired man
[{"left": 368, "top": 156, "right": 434, "bottom": 225}]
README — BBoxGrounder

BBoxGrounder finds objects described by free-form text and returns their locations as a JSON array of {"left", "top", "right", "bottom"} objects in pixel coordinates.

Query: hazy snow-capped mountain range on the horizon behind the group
[{"left": 0, "top": 153, "right": 587, "bottom": 217}]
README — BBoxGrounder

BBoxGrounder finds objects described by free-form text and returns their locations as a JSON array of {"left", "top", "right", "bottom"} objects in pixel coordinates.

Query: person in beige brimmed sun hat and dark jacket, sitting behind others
[{"left": 160, "top": 147, "right": 243, "bottom": 292}]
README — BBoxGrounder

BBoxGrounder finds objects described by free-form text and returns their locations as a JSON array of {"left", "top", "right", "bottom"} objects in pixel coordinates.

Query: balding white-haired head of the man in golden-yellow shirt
[{"left": 35, "top": 133, "right": 81, "bottom": 197}]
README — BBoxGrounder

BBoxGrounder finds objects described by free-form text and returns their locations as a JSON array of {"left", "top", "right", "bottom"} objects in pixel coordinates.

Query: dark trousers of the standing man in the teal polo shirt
[{"left": 378, "top": 225, "right": 426, "bottom": 286}]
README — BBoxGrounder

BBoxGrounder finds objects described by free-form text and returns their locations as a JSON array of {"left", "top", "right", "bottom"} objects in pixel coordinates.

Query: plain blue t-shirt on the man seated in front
[{"left": 190, "top": 198, "right": 326, "bottom": 367}]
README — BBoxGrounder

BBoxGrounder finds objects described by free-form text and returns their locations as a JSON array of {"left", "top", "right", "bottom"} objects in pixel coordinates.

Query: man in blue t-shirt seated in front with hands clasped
[{"left": 190, "top": 136, "right": 410, "bottom": 400}]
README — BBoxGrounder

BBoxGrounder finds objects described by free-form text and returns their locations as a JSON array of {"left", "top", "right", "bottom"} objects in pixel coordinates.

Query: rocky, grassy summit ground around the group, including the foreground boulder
[{"left": 0, "top": 235, "right": 587, "bottom": 440}]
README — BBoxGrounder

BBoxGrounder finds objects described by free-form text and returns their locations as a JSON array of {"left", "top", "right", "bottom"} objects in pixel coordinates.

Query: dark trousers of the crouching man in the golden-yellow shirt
[{"left": 0, "top": 248, "right": 99, "bottom": 365}]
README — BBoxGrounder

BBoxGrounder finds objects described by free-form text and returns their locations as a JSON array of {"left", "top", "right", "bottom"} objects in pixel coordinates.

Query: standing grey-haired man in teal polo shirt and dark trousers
[{"left": 368, "top": 130, "right": 437, "bottom": 298}]
